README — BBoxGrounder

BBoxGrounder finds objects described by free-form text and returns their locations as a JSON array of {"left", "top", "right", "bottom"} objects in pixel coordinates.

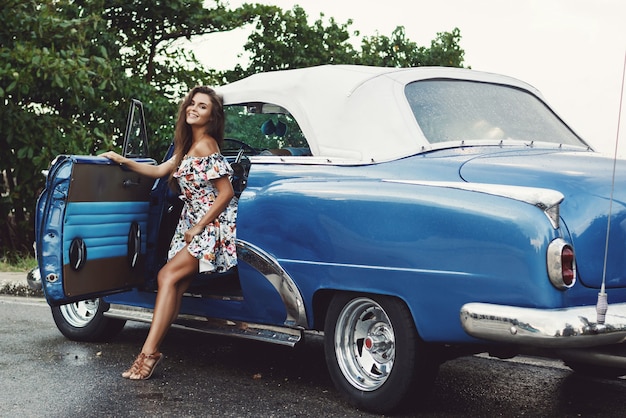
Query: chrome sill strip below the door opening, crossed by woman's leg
[{"left": 104, "top": 304, "right": 302, "bottom": 347}]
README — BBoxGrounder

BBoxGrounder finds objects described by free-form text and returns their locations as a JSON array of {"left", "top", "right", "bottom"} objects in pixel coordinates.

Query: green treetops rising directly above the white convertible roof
[{"left": 224, "top": 6, "right": 465, "bottom": 81}]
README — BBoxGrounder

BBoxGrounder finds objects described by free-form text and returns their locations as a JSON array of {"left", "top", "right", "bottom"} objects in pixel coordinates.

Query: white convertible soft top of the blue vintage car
[{"left": 218, "top": 65, "right": 543, "bottom": 163}]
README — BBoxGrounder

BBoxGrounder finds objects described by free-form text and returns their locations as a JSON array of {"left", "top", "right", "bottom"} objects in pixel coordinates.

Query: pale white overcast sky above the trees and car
[{"left": 193, "top": 0, "right": 626, "bottom": 158}]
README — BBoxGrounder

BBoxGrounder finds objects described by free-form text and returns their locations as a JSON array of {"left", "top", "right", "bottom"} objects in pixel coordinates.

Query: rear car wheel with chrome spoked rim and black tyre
[{"left": 324, "top": 294, "right": 439, "bottom": 413}]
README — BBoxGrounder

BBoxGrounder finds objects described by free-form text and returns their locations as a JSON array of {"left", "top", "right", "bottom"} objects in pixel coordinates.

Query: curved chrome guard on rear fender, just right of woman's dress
[{"left": 237, "top": 240, "right": 308, "bottom": 328}]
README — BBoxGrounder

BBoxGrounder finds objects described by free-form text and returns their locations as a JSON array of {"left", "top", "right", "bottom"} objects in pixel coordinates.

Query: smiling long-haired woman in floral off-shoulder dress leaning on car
[{"left": 102, "top": 86, "right": 237, "bottom": 380}]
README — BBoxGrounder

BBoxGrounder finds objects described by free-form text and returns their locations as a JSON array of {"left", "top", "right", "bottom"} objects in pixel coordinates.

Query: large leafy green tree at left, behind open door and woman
[{"left": 0, "top": 0, "right": 263, "bottom": 254}]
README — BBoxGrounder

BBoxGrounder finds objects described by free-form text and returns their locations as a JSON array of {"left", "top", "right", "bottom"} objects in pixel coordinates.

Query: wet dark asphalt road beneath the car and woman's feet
[{"left": 0, "top": 296, "right": 626, "bottom": 418}]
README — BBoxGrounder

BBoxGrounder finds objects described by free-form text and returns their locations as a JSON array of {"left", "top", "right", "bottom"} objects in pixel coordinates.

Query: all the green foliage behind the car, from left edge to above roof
[{"left": 0, "top": 0, "right": 463, "bottom": 255}]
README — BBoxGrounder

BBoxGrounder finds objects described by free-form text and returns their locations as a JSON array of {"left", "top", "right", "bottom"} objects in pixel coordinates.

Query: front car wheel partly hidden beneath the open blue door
[{"left": 52, "top": 299, "right": 126, "bottom": 341}]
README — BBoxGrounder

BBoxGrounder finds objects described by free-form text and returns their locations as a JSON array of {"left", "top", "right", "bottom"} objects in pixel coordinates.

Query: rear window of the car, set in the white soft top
[{"left": 405, "top": 80, "right": 586, "bottom": 146}]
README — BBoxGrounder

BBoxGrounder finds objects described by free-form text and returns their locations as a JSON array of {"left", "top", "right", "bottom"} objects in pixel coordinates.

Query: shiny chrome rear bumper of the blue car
[{"left": 461, "top": 303, "right": 626, "bottom": 348}]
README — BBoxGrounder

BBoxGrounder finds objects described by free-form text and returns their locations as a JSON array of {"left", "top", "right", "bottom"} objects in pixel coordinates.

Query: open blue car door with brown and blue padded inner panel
[{"left": 36, "top": 100, "right": 155, "bottom": 305}]
